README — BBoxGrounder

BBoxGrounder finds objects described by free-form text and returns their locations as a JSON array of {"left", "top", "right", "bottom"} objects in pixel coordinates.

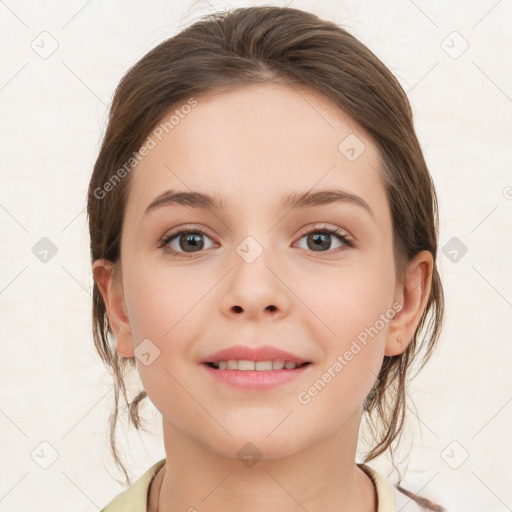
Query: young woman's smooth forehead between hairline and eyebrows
[{"left": 127, "top": 84, "right": 385, "bottom": 216}]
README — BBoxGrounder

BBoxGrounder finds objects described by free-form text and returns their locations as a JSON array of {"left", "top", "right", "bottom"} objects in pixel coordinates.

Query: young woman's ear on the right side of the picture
[{"left": 384, "top": 251, "right": 434, "bottom": 356}]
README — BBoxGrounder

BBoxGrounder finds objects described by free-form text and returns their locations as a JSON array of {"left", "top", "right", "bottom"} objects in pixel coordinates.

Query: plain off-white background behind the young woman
[{"left": 0, "top": 0, "right": 512, "bottom": 512}]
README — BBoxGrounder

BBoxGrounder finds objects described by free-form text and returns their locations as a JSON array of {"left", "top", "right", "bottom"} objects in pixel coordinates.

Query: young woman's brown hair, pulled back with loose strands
[{"left": 87, "top": 6, "right": 444, "bottom": 508}]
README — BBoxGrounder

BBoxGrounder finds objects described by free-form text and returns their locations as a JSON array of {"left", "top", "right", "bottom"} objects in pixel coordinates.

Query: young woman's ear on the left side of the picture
[{"left": 92, "top": 259, "right": 134, "bottom": 357}]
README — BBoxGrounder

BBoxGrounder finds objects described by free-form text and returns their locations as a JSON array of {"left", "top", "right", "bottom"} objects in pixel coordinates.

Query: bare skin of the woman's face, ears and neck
[{"left": 93, "top": 84, "right": 433, "bottom": 512}]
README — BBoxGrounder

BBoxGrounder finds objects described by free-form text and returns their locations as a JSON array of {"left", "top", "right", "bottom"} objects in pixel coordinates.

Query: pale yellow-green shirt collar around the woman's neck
[{"left": 101, "top": 459, "right": 421, "bottom": 512}]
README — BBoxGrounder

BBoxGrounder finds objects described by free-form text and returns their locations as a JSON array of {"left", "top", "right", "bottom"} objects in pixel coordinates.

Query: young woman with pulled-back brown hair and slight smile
[{"left": 88, "top": 6, "right": 443, "bottom": 512}]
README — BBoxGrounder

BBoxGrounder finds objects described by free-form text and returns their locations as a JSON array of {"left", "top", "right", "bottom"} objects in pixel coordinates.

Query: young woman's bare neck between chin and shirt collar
[{"left": 149, "top": 414, "right": 377, "bottom": 512}]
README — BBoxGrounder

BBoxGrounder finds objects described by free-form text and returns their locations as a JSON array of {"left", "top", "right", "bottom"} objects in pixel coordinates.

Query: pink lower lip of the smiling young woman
[{"left": 201, "top": 363, "right": 311, "bottom": 391}]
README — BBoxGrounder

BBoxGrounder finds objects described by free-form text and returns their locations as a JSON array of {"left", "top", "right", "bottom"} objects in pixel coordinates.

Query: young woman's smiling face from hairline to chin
[{"left": 98, "top": 84, "right": 414, "bottom": 458}]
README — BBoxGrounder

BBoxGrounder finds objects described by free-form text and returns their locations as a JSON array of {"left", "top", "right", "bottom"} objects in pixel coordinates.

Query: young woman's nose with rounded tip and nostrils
[{"left": 221, "top": 244, "right": 290, "bottom": 320}]
